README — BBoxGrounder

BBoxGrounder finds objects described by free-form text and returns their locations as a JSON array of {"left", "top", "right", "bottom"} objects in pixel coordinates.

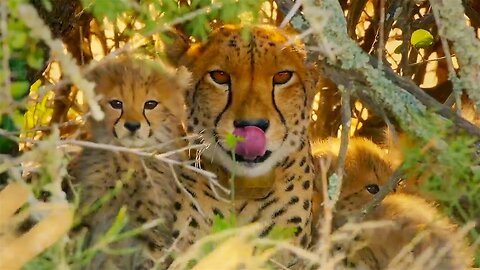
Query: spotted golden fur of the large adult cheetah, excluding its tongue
[{"left": 167, "top": 26, "right": 317, "bottom": 262}]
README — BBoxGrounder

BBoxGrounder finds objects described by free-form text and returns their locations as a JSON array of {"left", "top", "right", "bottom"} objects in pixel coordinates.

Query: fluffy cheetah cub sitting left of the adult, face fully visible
[{"left": 69, "top": 57, "right": 190, "bottom": 269}]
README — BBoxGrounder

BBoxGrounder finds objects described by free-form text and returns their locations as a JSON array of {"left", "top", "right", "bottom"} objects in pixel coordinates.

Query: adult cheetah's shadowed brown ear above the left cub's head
[{"left": 163, "top": 28, "right": 190, "bottom": 66}]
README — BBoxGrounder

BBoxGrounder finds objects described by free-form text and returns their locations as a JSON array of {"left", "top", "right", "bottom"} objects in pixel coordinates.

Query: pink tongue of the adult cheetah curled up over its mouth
[{"left": 233, "top": 126, "right": 267, "bottom": 160}]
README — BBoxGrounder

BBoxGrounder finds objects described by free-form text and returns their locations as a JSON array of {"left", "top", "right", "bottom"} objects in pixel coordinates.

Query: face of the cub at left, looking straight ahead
[{"left": 92, "top": 60, "right": 190, "bottom": 147}]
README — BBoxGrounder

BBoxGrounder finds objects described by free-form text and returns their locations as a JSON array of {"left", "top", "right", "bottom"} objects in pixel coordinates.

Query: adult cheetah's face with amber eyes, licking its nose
[{"left": 183, "top": 26, "right": 316, "bottom": 176}]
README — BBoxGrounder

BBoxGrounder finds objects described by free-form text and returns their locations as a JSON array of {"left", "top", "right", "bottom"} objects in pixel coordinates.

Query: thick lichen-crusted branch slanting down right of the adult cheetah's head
[{"left": 303, "top": 0, "right": 430, "bottom": 138}]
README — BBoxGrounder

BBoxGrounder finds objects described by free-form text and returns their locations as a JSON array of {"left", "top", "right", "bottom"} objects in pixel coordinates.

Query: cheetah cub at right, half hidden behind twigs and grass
[{"left": 312, "top": 138, "right": 472, "bottom": 270}]
